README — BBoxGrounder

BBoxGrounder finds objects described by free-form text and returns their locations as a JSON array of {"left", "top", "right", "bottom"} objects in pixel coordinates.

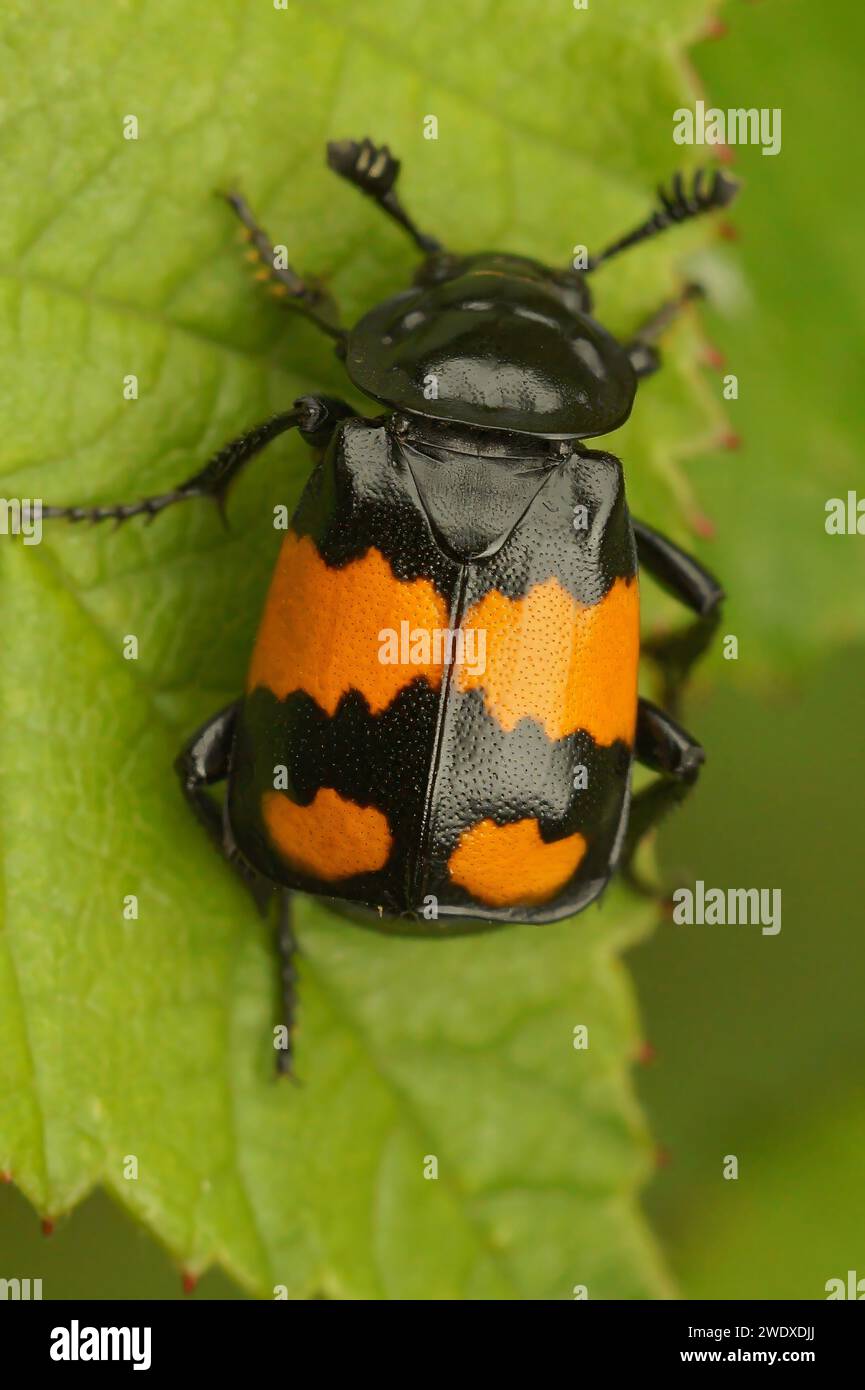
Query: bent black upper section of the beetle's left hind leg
[{"left": 174, "top": 701, "right": 274, "bottom": 916}]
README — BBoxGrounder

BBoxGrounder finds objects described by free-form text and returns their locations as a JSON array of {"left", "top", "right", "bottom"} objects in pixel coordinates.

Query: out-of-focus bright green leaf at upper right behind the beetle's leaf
[{"left": 681, "top": 0, "right": 865, "bottom": 682}]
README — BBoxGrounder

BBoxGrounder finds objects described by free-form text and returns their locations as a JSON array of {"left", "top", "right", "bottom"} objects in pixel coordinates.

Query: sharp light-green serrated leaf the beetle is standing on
[{"left": 0, "top": 0, "right": 739, "bottom": 1298}]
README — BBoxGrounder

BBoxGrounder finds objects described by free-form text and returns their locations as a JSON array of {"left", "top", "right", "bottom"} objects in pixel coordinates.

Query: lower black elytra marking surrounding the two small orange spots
[{"left": 229, "top": 678, "right": 630, "bottom": 920}]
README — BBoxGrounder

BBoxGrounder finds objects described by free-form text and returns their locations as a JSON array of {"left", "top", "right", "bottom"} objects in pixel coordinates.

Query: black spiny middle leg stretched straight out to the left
[{"left": 42, "top": 396, "right": 355, "bottom": 523}]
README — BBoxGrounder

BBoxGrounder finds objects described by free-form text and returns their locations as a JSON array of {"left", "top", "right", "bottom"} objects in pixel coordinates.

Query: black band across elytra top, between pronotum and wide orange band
[{"left": 293, "top": 420, "right": 637, "bottom": 603}]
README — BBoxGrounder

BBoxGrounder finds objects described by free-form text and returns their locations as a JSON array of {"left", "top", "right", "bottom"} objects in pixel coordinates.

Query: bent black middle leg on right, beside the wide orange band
[{"left": 633, "top": 521, "right": 725, "bottom": 710}]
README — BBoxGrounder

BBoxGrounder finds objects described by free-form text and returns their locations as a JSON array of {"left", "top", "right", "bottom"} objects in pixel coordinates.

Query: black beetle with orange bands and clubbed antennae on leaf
[{"left": 43, "top": 139, "right": 736, "bottom": 1074}]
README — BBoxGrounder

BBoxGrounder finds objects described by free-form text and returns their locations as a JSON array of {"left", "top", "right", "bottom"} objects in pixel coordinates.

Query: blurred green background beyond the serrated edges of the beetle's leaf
[{"left": 0, "top": 0, "right": 865, "bottom": 1298}]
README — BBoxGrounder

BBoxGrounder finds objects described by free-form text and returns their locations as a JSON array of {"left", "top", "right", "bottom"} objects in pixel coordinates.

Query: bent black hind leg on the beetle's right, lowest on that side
[{"left": 620, "top": 699, "right": 705, "bottom": 897}]
